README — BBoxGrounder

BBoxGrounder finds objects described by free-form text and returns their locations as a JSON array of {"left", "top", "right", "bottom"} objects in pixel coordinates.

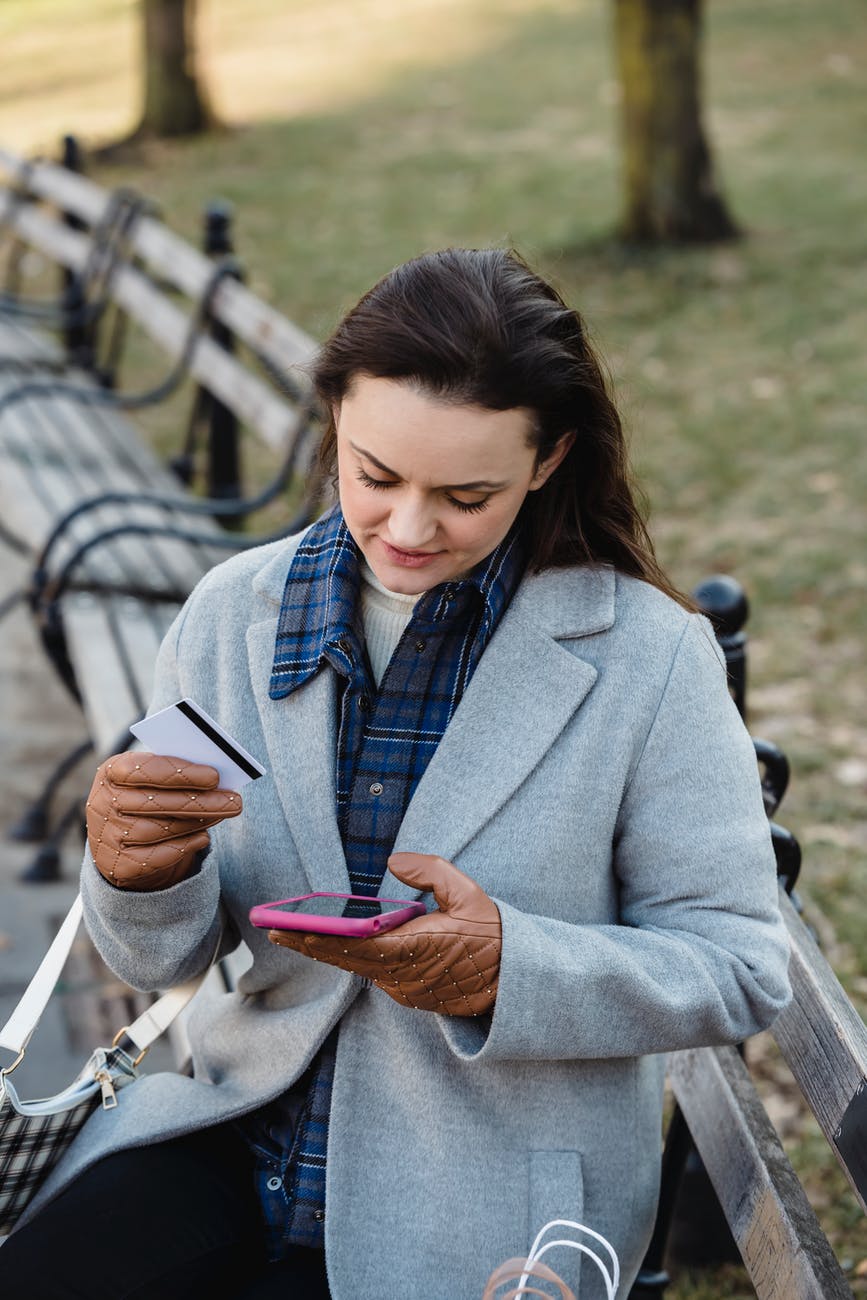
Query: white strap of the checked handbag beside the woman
[{"left": 0, "top": 894, "right": 217, "bottom": 1057}]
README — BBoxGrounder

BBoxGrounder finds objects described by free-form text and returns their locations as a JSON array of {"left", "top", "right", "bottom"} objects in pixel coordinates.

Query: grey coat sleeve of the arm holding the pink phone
[{"left": 439, "top": 618, "right": 790, "bottom": 1061}]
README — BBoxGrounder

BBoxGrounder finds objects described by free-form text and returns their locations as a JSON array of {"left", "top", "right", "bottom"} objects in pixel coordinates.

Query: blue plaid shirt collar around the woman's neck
[{"left": 269, "top": 507, "right": 523, "bottom": 699}]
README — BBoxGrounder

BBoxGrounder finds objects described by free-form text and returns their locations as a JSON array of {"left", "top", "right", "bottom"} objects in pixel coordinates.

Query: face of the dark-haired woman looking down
[{"left": 334, "top": 374, "right": 571, "bottom": 595}]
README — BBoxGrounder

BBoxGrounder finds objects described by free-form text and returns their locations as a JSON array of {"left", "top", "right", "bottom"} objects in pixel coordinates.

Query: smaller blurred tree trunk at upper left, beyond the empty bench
[{"left": 135, "top": 0, "right": 213, "bottom": 138}]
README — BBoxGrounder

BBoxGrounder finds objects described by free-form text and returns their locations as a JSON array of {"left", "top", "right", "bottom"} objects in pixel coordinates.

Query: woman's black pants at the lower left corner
[{"left": 0, "top": 1126, "right": 329, "bottom": 1300}]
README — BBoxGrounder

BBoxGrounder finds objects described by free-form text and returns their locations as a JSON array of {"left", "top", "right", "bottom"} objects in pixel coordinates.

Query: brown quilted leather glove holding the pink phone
[{"left": 268, "top": 853, "right": 502, "bottom": 1015}]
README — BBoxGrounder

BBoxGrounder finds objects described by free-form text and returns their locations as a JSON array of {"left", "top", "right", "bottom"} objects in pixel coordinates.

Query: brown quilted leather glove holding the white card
[{"left": 87, "top": 753, "right": 242, "bottom": 891}]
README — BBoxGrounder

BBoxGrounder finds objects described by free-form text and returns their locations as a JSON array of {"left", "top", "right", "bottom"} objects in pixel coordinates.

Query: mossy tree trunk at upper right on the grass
[{"left": 615, "top": 0, "right": 738, "bottom": 243}]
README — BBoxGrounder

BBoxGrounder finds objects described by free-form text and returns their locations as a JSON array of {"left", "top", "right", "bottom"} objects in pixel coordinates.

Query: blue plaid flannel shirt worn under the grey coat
[{"left": 239, "top": 510, "right": 523, "bottom": 1258}]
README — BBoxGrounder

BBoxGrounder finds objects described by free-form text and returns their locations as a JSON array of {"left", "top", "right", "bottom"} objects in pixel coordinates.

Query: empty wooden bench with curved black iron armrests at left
[{"left": 0, "top": 139, "right": 318, "bottom": 876}]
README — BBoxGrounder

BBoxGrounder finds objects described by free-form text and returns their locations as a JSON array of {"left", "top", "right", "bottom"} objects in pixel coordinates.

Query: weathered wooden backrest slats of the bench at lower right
[{"left": 669, "top": 891, "right": 867, "bottom": 1300}]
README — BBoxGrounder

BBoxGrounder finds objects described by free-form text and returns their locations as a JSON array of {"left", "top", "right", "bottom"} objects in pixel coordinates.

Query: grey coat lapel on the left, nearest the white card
[{"left": 247, "top": 618, "right": 350, "bottom": 893}]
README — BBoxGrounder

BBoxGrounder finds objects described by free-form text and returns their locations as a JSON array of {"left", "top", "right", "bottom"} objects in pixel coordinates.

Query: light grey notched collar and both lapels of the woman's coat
[{"left": 247, "top": 547, "right": 616, "bottom": 898}]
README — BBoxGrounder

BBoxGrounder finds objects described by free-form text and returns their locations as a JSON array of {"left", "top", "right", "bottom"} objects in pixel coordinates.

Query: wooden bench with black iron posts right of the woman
[{"left": 630, "top": 580, "right": 867, "bottom": 1300}]
